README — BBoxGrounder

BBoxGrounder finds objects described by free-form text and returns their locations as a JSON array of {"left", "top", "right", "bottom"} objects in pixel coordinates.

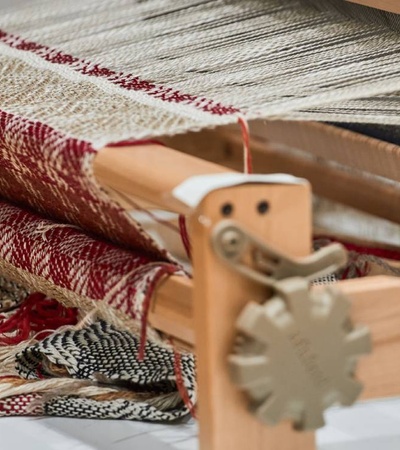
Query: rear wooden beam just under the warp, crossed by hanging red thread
[{"left": 163, "top": 120, "right": 400, "bottom": 185}]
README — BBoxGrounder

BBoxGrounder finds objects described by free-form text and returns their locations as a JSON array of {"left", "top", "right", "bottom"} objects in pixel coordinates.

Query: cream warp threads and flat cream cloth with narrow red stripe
[{"left": 0, "top": 0, "right": 400, "bottom": 141}]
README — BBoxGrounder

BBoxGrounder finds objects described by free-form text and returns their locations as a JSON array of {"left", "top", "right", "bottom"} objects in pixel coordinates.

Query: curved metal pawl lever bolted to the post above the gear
[{"left": 211, "top": 220, "right": 347, "bottom": 286}]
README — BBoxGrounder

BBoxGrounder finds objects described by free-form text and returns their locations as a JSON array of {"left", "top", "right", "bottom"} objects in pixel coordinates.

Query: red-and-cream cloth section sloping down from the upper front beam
[{"left": 0, "top": 110, "right": 168, "bottom": 260}]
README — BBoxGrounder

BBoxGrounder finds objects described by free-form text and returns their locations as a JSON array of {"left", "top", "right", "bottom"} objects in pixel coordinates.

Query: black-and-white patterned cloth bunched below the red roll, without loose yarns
[{"left": 16, "top": 321, "right": 196, "bottom": 421}]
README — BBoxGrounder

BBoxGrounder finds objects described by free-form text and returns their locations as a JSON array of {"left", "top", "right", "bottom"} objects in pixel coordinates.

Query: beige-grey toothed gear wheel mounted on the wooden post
[{"left": 229, "top": 277, "right": 371, "bottom": 430}]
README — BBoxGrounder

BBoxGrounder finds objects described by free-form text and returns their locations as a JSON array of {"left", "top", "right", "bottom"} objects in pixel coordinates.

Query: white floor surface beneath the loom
[{"left": 0, "top": 399, "right": 400, "bottom": 450}]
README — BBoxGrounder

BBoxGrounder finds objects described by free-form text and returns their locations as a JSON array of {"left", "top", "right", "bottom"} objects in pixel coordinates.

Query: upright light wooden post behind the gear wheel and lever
[{"left": 191, "top": 184, "right": 315, "bottom": 450}]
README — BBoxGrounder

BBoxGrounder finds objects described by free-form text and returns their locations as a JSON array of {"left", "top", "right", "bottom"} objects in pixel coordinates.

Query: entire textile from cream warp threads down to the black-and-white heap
[{"left": 0, "top": 0, "right": 400, "bottom": 421}]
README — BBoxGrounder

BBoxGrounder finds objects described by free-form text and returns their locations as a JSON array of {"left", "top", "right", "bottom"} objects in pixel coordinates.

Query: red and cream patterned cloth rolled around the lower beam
[{"left": 0, "top": 201, "right": 179, "bottom": 336}]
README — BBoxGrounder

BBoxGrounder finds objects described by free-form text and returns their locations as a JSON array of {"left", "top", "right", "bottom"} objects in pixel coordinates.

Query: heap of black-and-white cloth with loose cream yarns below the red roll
[{"left": 0, "top": 321, "right": 196, "bottom": 421}]
